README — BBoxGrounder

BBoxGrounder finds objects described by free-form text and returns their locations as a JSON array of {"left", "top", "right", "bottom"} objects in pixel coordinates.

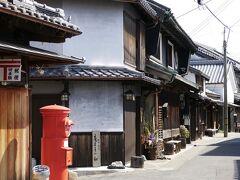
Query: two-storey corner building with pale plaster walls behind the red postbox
[{"left": 31, "top": 0, "right": 160, "bottom": 166}]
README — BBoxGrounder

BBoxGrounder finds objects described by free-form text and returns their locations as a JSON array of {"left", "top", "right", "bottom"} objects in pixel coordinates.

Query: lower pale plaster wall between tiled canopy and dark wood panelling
[{"left": 69, "top": 81, "right": 123, "bottom": 132}]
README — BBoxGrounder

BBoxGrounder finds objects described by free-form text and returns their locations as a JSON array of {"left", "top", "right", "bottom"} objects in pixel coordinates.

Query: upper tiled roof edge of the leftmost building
[{"left": 0, "top": 1, "right": 80, "bottom": 33}]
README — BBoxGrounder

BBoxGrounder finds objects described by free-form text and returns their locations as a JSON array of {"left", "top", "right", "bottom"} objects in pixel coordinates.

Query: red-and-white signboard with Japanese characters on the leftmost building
[{"left": 0, "top": 59, "right": 21, "bottom": 81}]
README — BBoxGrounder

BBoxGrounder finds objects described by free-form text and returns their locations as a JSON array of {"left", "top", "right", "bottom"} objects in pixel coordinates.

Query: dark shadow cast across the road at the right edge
[{"left": 201, "top": 138, "right": 240, "bottom": 179}]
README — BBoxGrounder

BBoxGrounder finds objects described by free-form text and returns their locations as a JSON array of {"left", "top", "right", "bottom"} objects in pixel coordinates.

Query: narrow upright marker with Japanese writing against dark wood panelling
[{"left": 92, "top": 131, "right": 101, "bottom": 167}]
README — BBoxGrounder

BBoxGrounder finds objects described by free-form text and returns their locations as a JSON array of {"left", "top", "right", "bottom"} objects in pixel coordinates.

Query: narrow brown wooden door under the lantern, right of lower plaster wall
[{"left": 124, "top": 100, "right": 136, "bottom": 162}]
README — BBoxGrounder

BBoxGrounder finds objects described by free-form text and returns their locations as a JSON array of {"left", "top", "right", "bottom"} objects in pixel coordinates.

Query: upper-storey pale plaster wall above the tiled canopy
[{"left": 63, "top": 0, "right": 123, "bottom": 66}]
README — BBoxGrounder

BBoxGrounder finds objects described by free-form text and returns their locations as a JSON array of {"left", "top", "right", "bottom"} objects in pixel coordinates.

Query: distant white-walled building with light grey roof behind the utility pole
[{"left": 190, "top": 44, "right": 239, "bottom": 134}]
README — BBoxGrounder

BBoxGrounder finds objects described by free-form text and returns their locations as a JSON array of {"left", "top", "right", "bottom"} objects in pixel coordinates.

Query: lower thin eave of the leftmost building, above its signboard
[{"left": 0, "top": 41, "right": 84, "bottom": 65}]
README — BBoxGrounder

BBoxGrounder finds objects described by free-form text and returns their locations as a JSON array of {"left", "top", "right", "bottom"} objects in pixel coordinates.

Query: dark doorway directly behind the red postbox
[{"left": 32, "top": 94, "right": 61, "bottom": 163}]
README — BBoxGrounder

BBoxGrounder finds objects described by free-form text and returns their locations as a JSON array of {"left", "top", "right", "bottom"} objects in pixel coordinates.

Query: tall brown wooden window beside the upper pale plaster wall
[{"left": 123, "top": 13, "right": 137, "bottom": 67}]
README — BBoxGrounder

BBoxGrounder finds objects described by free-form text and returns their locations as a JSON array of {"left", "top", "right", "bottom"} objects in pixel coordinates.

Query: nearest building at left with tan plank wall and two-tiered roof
[{"left": 0, "top": 0, "right": 82, "bottom": 179}]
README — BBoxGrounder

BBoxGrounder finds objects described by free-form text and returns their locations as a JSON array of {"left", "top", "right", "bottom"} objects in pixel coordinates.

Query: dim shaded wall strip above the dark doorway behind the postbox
[{"left": 29, "top": 81, "right": 64, "bottom": 94}]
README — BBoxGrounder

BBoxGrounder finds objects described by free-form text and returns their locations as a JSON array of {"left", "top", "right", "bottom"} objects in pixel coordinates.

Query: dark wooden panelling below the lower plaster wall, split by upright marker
[{"left": 69, "top": 132, "right": 124, "bottom": 167}]
